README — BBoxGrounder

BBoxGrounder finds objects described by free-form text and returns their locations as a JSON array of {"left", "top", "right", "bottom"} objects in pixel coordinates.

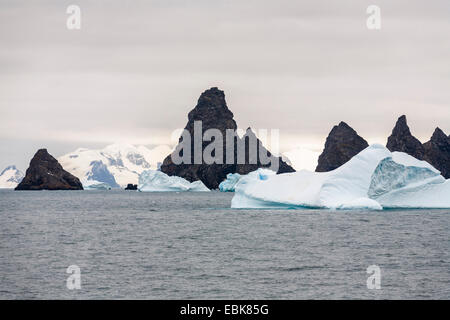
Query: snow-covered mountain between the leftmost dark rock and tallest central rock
[{"left": 58, "top": 144, "right": 171, "bottom": 188}]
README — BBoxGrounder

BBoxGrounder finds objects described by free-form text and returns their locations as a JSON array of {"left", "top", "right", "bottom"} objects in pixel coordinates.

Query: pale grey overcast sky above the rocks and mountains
[{"left": 0, "top": 0, "right": 450, "bottom": 171}]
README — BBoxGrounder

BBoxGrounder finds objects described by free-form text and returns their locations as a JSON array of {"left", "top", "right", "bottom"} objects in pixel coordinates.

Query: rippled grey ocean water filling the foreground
[{"left": 0, "top": 190, "right": 450, "bottom": 299}]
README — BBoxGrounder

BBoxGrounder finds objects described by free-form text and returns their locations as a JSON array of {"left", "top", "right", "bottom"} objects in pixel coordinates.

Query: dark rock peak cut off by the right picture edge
[{"left": 423, "top": 128, "right": 450, "bottom": 179}]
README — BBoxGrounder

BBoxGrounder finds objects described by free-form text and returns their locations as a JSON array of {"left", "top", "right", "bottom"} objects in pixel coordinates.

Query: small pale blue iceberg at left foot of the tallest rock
[{"left": 138, "top": 170, "right": 209, "bottom": 192}]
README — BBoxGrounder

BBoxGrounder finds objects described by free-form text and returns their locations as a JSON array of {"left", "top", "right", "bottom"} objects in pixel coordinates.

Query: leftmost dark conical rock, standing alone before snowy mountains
[{"left": 16, "top": 149, "right": 83, "bottom": 190}]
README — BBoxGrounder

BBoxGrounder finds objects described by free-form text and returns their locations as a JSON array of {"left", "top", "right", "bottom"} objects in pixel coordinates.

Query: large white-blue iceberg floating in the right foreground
[{"left": 231, "top": 145, "right": 450, "bottom": 210}]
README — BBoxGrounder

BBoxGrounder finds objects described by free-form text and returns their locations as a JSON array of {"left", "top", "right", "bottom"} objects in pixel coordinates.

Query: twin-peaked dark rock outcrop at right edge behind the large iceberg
[{"left": 386, "top": 115, "right": 450, "bottom": 179}]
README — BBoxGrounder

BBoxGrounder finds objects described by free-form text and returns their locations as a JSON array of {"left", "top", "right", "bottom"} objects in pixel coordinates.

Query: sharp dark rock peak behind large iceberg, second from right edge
[{"left": 386, "top": 115, "right": 424, "bottom": 160}]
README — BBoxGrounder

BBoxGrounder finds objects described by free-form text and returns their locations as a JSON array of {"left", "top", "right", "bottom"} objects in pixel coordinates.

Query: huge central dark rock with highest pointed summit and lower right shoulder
[{"left": 161, "top": 87, "right": 294, "bottom": 189}]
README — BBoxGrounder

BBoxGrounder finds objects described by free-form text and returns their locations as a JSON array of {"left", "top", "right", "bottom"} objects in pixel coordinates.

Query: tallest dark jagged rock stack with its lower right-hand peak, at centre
[{"left": 161, "top": 88, "right": 295, "bottom": 189}]
